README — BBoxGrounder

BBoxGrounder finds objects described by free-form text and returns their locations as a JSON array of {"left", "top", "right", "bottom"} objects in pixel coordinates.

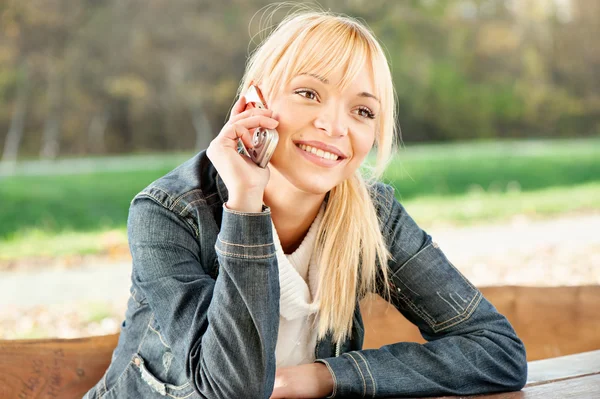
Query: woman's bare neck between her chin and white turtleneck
[{"left": 263, "top": 168, "right": 325, "bottom": 254}]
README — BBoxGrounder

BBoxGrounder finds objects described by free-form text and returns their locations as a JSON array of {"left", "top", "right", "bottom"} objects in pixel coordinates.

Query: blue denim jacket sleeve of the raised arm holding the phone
[{"left": 128, "top": 196, "right": 279, "bottom": 399}]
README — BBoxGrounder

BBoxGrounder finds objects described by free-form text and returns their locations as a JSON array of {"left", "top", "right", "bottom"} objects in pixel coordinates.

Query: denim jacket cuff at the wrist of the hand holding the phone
[{"left": 215, "top": 205, "right": 275, "bottom": 259}]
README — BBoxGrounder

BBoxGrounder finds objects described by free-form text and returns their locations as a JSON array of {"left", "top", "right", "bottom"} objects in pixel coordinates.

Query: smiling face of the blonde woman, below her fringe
[{"left": 268, "top": 67, "right": 380, "bottom": 194}]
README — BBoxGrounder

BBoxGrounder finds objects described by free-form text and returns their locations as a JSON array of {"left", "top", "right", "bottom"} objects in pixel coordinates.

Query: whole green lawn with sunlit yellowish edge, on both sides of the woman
[{"left": 0, "top": 138, "right": 600, "bottom": 260}]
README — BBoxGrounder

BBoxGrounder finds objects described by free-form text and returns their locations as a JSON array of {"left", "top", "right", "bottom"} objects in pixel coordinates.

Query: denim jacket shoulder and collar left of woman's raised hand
[{"left": 131, "top": 150, "right": 222, "bottom": 214}]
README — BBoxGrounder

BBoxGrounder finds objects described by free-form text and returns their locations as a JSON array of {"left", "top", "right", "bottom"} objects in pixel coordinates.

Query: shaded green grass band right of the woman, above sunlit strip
[{"left": 384, "top": 139, "right": 600, "bottom": 200}]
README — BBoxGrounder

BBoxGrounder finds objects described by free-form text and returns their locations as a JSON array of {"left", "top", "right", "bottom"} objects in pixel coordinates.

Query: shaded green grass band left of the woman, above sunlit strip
[{"left": 0, "top": 169, "right": 176, "bottom": 240}]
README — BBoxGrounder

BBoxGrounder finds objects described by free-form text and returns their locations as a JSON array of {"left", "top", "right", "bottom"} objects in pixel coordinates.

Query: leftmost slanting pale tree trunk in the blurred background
[{"left": 0, "top": 62, "right": 30, "bottom": 172}]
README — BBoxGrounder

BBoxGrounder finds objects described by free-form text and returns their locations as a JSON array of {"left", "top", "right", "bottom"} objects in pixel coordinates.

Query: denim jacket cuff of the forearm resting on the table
[{"left": 315, "top": 352, "right": 376, "bottom": 398}]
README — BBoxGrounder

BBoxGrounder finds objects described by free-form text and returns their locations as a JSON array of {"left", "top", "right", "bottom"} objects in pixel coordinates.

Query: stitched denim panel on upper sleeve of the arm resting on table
[{"left": 390, "top": 242, "right": 482, "bottom": 333}]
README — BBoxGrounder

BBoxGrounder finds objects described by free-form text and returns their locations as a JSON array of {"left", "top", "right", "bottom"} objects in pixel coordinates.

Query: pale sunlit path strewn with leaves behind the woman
[{"left": 0, "top": 214, "right": 600, "bottom": 338}]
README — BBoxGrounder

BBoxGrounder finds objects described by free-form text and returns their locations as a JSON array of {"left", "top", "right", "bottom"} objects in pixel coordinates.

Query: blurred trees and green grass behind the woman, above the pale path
[{"left": 0, "top": 0, "right": 600, "bottom": 264}]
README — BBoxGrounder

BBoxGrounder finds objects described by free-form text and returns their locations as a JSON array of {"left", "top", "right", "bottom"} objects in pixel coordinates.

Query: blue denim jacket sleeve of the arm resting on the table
[{"left": 316, "top": 186, "right": 527, "bottom": 397}]
